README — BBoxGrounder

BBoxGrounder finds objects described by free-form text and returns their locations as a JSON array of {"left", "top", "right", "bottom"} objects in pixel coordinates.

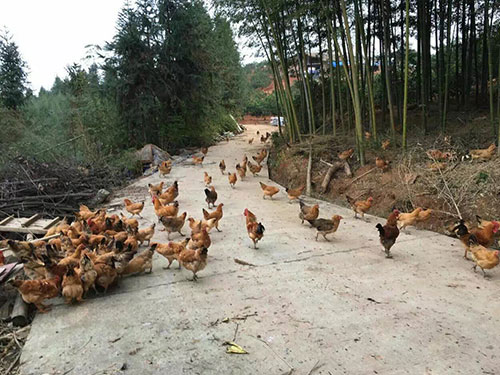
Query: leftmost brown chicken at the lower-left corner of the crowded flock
[{"left": 10, "top": 276, "right": 61, "bottom": 313}]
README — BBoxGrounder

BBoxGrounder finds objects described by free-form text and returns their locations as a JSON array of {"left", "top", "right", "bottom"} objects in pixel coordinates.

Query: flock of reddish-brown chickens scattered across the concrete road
[{"left": 4, "top": 132, "right": 500, "bottom": 312}]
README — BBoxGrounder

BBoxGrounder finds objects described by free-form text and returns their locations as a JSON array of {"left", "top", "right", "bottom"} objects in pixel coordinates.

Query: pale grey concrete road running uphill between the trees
[{"left": 21, "top": 126, "right": 500, "bottom": 375}]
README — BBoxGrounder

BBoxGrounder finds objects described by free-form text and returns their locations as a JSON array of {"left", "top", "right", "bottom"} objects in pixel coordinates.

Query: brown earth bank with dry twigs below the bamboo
[{"left": 268, "top": 112, "right": 500, "bottom": 238}]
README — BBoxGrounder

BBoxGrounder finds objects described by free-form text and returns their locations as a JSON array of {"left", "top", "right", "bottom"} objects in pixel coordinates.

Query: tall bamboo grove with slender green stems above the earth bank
[{"left": 213, "top": 0, "right": 500, "bottom": 163}]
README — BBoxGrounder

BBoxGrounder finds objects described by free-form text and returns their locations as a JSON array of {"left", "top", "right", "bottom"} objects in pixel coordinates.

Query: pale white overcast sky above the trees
[{"left": 0, "top": 0, "right": 262, "bottom": 93}]
